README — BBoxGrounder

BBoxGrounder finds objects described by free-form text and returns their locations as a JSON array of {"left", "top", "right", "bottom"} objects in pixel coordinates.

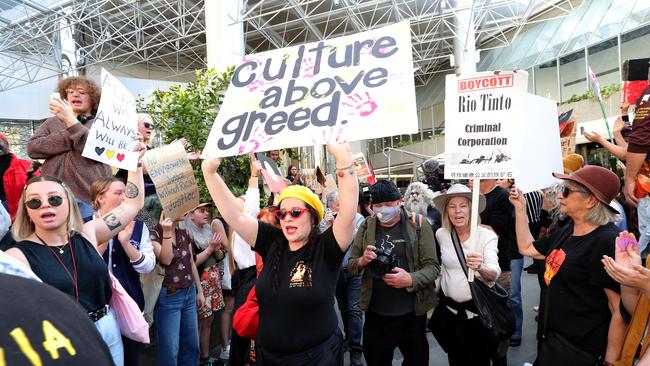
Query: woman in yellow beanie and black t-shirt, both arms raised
[{"left": 202, "top": 143, "right": 359, "bottom": 366}]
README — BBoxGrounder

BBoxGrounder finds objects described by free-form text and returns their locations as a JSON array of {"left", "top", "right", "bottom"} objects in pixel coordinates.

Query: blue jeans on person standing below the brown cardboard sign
[{"left": 153, "top": 284, "right": 199, "bottom": 366}]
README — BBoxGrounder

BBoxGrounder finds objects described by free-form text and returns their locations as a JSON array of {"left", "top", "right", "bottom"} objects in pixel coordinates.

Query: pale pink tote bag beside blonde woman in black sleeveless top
[{"left": 108, "top": 271, "right": 149, "bottom": 343}]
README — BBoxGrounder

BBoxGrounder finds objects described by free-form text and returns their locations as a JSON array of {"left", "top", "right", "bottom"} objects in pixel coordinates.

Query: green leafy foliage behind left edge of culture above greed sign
[{"left": 144, "top": 67, "right": 250, "bottom": 202}]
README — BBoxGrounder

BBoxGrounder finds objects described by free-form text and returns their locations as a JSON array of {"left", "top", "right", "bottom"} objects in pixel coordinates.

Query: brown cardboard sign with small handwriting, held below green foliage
[{"left": 142, "top": 142, "right": 200, "bottom": 220}]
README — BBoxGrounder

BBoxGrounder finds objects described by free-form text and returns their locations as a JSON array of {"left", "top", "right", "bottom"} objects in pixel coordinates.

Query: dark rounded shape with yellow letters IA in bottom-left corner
[{"left": 0, "top": 273, "right": 113, "bottom": 366}]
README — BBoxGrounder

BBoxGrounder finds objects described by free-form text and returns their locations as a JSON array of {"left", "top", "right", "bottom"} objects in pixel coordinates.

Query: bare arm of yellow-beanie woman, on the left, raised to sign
[{"left": 201, "top": 158, "right": 257, "bottom": 246}]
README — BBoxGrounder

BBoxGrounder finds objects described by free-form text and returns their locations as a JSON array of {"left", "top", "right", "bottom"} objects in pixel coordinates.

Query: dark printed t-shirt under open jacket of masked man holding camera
[{"left": 368, "top": 223, "right": 415, "bottom": 316}]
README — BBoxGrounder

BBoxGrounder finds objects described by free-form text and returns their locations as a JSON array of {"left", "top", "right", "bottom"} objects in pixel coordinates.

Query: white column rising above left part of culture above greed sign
[{"left": 205, "top": 0, "right": 245, "bottom": 71}]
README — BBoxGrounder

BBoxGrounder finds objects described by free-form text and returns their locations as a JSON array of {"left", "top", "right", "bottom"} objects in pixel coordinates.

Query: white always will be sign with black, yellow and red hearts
[{"left": 81, "top": 69, "right": 138, "bottom": 171}]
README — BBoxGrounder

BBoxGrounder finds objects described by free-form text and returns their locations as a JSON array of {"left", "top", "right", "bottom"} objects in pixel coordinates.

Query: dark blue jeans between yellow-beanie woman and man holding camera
[{"left": 336, "top": 270, "right": 363, "bottom": 352}]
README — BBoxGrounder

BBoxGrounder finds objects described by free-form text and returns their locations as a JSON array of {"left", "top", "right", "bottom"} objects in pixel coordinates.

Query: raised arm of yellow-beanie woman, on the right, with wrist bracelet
[{"left": 327, "top": 142, "right": 359, "bottom": 252}]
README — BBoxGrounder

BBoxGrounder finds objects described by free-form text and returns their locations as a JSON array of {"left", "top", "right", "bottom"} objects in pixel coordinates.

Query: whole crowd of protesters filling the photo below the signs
[{"left": 0, "top": 73, "right": 650, "bottom": 366}]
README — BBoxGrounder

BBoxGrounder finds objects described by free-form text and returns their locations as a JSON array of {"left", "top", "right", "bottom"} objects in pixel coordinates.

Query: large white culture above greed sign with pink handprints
[{"left": 203, "top": 21, "right": 418, "bottom": 157}]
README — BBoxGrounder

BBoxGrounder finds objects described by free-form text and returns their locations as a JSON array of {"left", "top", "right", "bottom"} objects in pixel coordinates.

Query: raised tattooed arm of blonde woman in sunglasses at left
[{"left": 83, "top": 133, "right": 146, "bottom": 245}]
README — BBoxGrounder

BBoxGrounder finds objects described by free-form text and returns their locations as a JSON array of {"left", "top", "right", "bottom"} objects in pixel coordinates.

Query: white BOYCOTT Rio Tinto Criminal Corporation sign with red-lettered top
[{"left": 445, "top": 71, "right": 528, "bottom": 179}]
